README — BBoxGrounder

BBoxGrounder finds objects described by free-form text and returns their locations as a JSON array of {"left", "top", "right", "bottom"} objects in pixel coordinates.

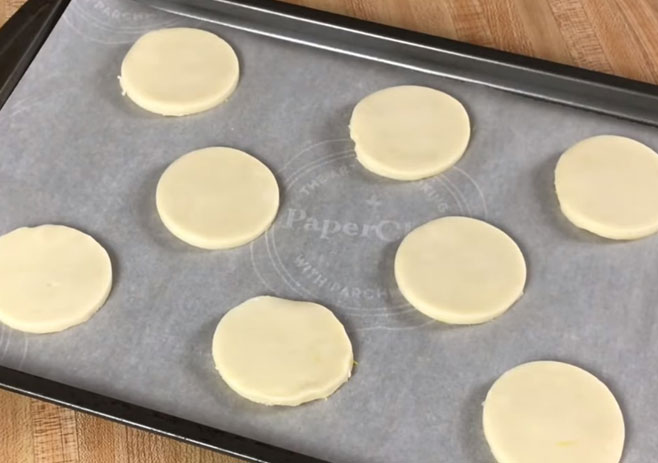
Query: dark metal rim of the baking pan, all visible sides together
[{"left": 0, "top": 0, "right": 658, "bottom": 463}]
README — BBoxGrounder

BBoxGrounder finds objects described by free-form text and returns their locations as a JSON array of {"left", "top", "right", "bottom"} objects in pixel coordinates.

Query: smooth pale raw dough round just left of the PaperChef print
[{"left": 156, "top": 147, "right": 279, "bottom": 249}]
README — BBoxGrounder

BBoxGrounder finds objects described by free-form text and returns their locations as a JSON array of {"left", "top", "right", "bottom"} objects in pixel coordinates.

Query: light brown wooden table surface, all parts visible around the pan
[{"left": 0, "top": 0, "right": 658, "bottom": 463}]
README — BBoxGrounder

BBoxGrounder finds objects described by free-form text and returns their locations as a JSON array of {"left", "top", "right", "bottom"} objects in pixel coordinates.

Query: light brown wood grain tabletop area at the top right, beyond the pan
[{"left": 284, "top": 0, "right": 658, "bottom": 84}]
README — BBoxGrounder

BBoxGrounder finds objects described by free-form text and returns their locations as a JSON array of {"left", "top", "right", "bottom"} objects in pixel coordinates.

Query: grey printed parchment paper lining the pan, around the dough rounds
[{"left": 0, "top": 0, "right": 658, "bottom": 463}]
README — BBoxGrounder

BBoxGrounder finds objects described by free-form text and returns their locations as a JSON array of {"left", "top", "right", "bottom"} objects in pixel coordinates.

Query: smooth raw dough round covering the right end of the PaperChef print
[{"left": 395, "top": 217, "right": 526, "bottom": 324}]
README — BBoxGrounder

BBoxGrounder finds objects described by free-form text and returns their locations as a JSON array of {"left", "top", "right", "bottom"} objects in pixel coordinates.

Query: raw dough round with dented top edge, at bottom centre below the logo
[{"left": 212, "top": 296, "right": 354, "bottom": 406}]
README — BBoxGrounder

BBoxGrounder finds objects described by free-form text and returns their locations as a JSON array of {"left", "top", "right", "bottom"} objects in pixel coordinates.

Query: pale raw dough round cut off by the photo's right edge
[{"left": 555, "top": 135, "right": 658, "bottom": 240}]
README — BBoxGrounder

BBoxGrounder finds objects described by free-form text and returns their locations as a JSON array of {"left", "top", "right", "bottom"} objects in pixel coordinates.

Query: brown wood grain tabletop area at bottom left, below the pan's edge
[{"left": 0, "top": 390, "right": 238, "bottom": 463}]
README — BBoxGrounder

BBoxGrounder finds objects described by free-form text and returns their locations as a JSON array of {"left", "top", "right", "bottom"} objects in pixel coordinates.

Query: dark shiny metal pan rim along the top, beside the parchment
[{"left": 138, "top": 0, "right": 658, "bottom": 126}]
